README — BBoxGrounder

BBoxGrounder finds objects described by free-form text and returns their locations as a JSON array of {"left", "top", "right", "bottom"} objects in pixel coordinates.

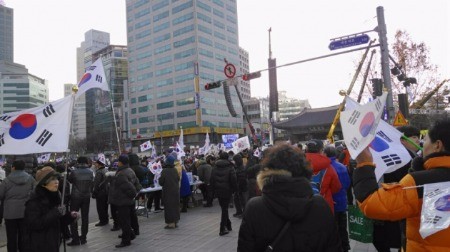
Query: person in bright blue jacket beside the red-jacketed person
[{"left": 324, "top": 145, "right": 350, "bottom": 251}]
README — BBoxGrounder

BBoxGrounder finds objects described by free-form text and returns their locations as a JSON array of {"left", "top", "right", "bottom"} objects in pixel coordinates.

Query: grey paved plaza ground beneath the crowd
[{"left": 0, "top": 200, "right": 376, "bottom": 252}]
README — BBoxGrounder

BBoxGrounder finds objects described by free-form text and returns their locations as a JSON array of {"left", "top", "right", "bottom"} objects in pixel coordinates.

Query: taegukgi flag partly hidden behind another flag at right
[{"left": 346, "top": 97, "right": 411, "bottom": 181}]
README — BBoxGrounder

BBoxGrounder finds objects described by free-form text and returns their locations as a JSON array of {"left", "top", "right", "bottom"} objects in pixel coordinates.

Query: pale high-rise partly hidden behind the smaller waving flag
[{"left": 72, "top": 30, "right": 109, "bottom": 144}]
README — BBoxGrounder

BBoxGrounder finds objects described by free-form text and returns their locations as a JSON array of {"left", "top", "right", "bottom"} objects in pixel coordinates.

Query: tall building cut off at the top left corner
[{"left": 0, "top": 4, "right": 14, "bottom": 62}]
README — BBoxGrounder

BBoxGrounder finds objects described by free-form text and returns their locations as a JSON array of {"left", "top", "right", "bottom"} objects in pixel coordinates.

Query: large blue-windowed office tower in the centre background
[{"left": 127, "top": 0, "right": 243, "bottom": 149}]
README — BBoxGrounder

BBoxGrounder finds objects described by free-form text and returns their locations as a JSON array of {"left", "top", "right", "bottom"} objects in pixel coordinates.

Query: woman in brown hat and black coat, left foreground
[{"left": 24, "top": 166, "right": 79, "bottom": 252}]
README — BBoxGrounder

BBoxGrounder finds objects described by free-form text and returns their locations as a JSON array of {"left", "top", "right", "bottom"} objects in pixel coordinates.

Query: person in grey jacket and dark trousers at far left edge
[{"left": 0, "top": 160, "right": 35, "bottom": 251}]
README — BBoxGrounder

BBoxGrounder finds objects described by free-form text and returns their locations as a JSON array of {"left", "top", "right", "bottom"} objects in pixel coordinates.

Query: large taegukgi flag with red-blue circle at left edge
[{"left": 0, "top": 96, "right": 73, "bottom": 155}]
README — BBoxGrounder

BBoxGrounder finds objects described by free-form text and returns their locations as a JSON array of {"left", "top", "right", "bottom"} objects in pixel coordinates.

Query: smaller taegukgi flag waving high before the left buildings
[{"left": 75, "top": 58, "right": 109, "bottom": 98}]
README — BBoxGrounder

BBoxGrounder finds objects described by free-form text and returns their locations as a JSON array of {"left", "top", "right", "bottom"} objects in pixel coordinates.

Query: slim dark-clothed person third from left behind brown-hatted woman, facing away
[{"left": 92, "top": 159, "right": 109, "bottom": 227}]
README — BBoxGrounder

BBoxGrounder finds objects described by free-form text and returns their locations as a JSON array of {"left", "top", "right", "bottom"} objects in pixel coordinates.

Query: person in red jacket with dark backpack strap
[{"left": 305, "top": 139, "right": 342, "bottom": 213}]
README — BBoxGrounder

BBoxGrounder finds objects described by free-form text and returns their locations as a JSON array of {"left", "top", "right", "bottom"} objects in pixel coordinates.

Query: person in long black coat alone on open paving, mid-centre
[{"left": 210, "top": 152, "right": 237, "bottom": 236}]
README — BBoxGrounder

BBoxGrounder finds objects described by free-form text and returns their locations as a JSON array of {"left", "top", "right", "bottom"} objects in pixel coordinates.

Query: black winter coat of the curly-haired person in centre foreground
[{"left": 237, "top": 170, "right": 341, "bottom": 252}]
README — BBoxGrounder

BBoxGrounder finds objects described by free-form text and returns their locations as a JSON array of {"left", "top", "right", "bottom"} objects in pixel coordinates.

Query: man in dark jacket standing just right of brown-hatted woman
[{"left": 67, "top": 157, "right": 94, "bottom": 246}]
